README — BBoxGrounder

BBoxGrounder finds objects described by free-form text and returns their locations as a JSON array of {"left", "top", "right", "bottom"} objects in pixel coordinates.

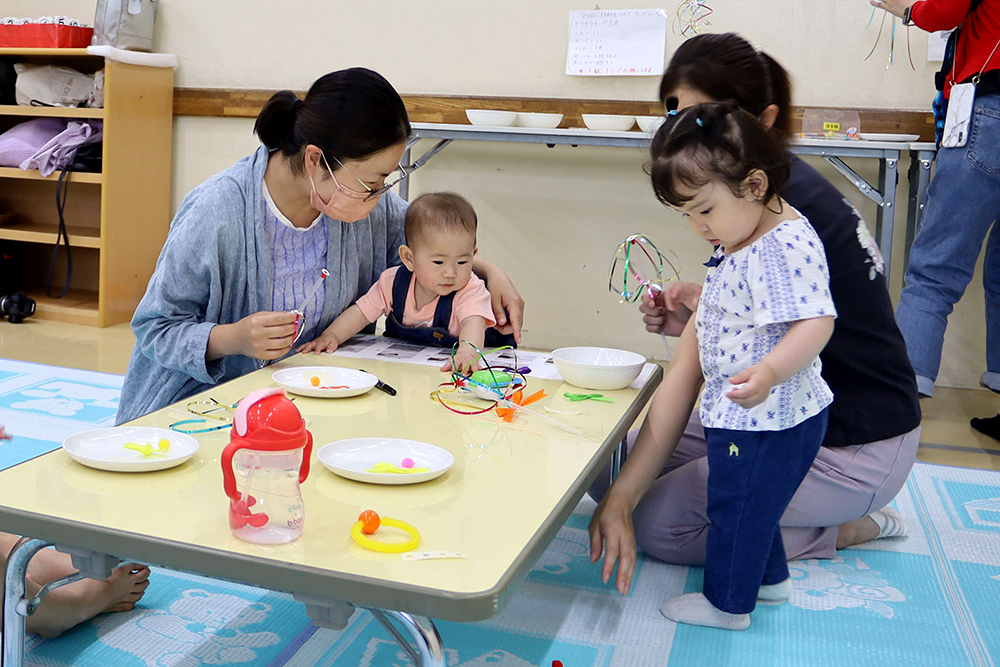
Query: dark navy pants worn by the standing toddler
[{"left": 705, "top": 410, "right": 830, "bottom": 614}]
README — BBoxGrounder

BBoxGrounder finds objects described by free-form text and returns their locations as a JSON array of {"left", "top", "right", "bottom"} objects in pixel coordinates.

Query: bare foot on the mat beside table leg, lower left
[{"left": 27, "top": 563, "right": 149, "bottom": 638}]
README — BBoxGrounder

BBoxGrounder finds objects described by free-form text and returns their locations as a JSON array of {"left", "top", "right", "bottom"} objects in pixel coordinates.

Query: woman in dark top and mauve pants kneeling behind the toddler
[{"left": 590, "top": 33, "right": 920, "bottom": 591}]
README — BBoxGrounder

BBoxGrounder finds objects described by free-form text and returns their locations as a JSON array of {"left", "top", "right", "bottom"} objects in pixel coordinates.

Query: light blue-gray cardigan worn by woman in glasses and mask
[{"left": 116, "top": 146, "right": 406, "bottom": 424}]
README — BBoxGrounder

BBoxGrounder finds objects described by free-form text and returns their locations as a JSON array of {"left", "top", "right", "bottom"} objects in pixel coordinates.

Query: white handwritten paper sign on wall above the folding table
[{"left": 566, "top": 9, "right": 667, "bottom": 76}]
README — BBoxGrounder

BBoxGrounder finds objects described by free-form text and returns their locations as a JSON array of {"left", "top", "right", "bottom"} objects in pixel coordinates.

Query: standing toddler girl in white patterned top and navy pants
[{"left": 636, "top": 100, "right": 836, "bottom": 630}]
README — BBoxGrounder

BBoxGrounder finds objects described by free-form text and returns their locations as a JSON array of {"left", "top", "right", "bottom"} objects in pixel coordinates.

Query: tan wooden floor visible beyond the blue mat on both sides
[{"left": 0, "top": 320, "right": 1000, "bottom": 470}]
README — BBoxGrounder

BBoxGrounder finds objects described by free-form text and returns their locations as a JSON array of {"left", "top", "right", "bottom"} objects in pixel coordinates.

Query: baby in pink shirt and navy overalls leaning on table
[{"left": 299, "top": 192, "right": 496, "bottom": 370}]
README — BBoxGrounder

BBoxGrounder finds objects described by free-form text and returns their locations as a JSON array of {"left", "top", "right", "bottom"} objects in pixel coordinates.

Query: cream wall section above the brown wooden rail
[{"left": 0, "top": 0, "right": 936, "bottom": 109}]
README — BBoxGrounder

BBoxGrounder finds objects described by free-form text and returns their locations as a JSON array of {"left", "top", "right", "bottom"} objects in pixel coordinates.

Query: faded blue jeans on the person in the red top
[{"left": 896, "top": 95, "right": 1000, "bottom": 396}]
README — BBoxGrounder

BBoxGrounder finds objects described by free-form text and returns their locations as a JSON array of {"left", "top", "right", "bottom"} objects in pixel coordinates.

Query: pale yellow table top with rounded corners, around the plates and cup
[{"left": 0, "top": 356, "right": 662, "bottom": 621}]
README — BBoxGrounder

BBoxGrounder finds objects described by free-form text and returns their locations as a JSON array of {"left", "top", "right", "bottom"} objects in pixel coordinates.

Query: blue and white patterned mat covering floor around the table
[{"left": 7, "top": 360, "right": 1000, "bottom": 667}]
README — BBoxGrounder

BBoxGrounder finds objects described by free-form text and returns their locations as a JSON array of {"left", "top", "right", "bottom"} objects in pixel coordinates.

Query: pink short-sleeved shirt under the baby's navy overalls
[{"left": 357, "top": 266, "right": 496, "bottom": 337}]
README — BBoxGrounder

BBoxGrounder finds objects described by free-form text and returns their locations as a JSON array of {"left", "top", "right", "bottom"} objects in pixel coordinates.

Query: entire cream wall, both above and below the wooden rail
[{"left": 9, "top": 0, "right": 985, "bottom": 386}]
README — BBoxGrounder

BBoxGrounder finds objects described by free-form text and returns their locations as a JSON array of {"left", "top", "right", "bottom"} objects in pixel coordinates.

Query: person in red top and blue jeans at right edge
[{"left": 871, "top": 0, "right": 1000, "bottom": 440}]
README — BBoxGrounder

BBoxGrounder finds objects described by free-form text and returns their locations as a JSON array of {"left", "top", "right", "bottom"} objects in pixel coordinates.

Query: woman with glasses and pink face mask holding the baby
[{"left": 117, "top": 68, "right": 523, "bottom": 424}]
